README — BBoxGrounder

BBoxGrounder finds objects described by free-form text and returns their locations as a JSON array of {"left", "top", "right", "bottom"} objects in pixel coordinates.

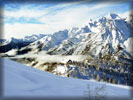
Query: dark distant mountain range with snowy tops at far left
[{"left": 0, "top": 34, "right": 45, "bottom": 53}]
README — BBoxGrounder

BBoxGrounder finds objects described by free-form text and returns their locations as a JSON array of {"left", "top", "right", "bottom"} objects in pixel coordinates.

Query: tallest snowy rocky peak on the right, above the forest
[{"left": 74, "top": 14, "right": 131, "bottom": 56}]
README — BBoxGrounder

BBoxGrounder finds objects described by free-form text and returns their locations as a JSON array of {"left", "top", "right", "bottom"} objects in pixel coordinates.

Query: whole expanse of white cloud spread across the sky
[{"left": 4, "top": 2, "right": 130, "bottom": 38}]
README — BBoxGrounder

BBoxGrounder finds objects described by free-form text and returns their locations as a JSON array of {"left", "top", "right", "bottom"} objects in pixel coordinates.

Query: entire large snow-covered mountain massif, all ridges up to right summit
[{"left": 22, "top": 14, "right": 132, "bottom": 58}]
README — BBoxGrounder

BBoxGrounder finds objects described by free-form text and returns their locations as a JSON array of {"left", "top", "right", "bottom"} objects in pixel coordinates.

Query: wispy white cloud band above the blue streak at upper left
[{"left": 3, "top": 2, "right": 83, "bottom": 19}]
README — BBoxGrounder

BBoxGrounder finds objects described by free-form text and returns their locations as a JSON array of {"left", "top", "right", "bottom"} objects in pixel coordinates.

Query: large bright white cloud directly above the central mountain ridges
[{"left": 39, "top": 3, "right": 116, "bottom": 29}]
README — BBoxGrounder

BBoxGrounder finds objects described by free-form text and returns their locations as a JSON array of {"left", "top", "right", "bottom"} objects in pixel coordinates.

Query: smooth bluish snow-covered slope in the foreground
[{"left": 0, "top": 58, "right": 133, "bottom": 100}]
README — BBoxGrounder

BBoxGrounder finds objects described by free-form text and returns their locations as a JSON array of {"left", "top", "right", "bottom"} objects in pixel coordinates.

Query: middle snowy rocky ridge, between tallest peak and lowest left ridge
[{"left": 48, "top": 26, "right": 90, "bottom": 55}]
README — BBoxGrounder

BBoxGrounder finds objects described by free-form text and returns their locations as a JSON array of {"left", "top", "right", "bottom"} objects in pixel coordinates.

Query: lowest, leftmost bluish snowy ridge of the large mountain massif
[{"left": 28, "top": 30, "right": 68, "bottom": 51}]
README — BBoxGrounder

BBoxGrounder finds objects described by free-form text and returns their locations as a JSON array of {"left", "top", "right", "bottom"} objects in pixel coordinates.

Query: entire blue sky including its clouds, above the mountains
[{"left": 3, "top": 1, "right": 130, "bottom": 38}]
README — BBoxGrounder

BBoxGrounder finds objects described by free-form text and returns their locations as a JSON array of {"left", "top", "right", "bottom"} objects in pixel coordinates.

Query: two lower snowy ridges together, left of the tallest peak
[{"left": 15, "top": 26, "right": 94, "bottom": 54}]
